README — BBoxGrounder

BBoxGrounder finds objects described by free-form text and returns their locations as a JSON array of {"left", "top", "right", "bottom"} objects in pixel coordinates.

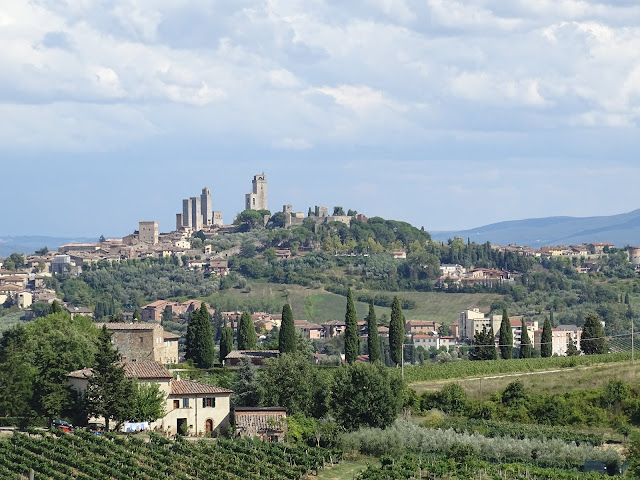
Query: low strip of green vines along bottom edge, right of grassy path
[{"left": 357, "top": 455, "right": 610, "bottom": 480}]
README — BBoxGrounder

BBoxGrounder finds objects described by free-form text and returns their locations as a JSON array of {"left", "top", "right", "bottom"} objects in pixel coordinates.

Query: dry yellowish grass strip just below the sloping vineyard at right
[{"left": 411, "top": 363, "right": 640, "bottom": 399}]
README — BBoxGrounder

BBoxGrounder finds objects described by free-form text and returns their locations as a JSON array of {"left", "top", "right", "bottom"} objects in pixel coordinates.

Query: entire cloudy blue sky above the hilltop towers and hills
[{"left": 0, "top": 0, "right": 640, "bottom": 237}]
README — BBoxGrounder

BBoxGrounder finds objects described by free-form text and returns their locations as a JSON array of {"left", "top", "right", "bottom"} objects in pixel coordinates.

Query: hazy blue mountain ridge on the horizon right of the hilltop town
[{"left": 430, "top": 209, "right": 640, "bottom": 248}]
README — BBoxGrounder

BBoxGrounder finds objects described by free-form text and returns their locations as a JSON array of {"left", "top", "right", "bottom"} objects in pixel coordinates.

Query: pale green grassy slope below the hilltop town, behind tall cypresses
[{"left": 202, "top": 282, "right": 500, "bottom": 324}]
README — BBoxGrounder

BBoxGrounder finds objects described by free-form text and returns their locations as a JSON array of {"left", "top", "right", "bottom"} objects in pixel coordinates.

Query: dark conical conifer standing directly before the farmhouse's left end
[{"left": 87, "top": 325, "right": 134, "bottom": 430}]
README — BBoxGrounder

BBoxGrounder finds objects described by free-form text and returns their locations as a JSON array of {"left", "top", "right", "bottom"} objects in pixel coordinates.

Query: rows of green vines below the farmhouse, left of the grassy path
[{"left": 0, "top": 431, "right": 336, "bottom": 480}]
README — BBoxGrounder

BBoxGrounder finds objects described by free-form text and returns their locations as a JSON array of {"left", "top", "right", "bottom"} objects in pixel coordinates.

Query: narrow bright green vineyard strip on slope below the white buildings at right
[{"left": 404, "top": 352, "right": 631, "bottom": 383}]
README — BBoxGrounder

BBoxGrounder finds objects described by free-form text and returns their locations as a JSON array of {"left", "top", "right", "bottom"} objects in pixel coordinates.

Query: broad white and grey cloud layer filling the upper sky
[{"left": 0, "top": 0, "right": 640, "bottom": 150}]
